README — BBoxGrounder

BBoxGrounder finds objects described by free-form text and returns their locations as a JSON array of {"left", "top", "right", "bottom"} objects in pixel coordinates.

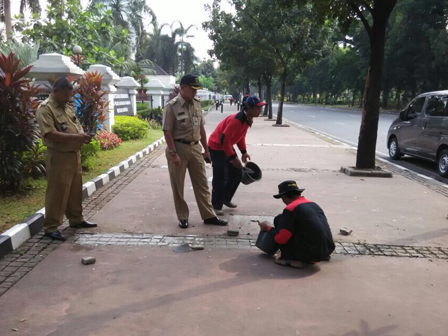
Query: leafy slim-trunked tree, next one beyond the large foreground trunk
[{"left": 205, "top": 0, "right": 325, "bottom": 124}]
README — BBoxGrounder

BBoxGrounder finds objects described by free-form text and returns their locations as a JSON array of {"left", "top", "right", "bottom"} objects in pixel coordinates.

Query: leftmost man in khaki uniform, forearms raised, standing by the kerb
[{"left": 36, "top": 77, "right": 97, "bottom": 241}]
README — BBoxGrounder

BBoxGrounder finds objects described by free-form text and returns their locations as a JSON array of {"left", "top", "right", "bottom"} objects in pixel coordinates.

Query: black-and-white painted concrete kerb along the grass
[{"left": 0, "top": 137, "right": 165, "bottom": 257}]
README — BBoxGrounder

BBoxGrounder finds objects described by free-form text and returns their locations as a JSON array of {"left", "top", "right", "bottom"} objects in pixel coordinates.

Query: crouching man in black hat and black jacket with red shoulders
[{"left": 260, "top": 181, "right": 335, "bottom": 268}]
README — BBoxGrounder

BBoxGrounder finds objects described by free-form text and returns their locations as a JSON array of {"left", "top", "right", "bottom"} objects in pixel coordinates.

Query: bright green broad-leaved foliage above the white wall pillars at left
[{"left": 14, "top": 0, "right": 131, "bottom": 72}]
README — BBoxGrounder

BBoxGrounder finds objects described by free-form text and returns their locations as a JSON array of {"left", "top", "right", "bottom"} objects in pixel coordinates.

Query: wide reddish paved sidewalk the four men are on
[{"left": 0, "top": 104, "right": 448, "bottom": 336}]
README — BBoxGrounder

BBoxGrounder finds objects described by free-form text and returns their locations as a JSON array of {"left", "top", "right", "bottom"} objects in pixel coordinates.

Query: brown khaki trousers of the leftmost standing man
[{"left": 43, "top": 148, "right": 84, "bottom": 233}]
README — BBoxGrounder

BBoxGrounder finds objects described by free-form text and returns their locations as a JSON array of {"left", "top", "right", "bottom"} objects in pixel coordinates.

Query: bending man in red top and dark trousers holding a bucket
[{"left": 208, "top": 96, "right": 266, "bottom": 216}]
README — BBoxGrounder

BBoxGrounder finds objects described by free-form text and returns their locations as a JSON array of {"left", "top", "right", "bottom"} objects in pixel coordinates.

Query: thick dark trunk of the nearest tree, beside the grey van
[{"left": 356, "top": 11, "right": 393, "bottom": 169}]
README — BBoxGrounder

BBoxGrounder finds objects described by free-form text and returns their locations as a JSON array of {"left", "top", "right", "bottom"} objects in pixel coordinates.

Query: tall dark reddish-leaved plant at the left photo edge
[{"left": 0, "top": 53, "right": 40, "bottom": 193}]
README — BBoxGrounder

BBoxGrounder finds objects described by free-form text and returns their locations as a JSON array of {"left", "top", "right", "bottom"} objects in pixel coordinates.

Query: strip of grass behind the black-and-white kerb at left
[{"left": 0, "top": 130, "right": 163, "bottom": 233}]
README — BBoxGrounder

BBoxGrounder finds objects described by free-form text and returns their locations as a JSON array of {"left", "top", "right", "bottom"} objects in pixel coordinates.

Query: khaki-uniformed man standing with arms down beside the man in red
[{"left": 163, "top": 75, "right": 227, "bottom": 229}]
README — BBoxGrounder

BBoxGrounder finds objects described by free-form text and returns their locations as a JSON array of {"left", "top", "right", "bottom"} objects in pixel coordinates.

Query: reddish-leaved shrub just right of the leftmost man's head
[{"left": 75, "top": 71, "right": 109, "bottom": 137}]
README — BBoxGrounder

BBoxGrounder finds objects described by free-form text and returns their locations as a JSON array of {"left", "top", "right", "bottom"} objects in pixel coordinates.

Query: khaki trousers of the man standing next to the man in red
[{"left": 165, "top": 142, "right": 216, "bottom": 220}]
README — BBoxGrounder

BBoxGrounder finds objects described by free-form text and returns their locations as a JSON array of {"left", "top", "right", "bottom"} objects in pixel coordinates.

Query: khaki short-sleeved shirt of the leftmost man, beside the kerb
[{"left": 36, "top": 95, "right": 83, "bottom": 152}]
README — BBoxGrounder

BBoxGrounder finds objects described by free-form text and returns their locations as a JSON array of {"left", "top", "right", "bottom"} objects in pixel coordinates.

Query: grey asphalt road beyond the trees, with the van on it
[{"left": 273, "top": 104, "right": 448, "bottom": 184}]
